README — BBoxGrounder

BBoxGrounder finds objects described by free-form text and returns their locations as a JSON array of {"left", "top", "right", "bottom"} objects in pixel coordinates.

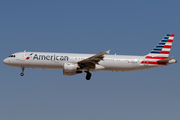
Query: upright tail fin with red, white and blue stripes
[{"left": 146, "top": 34, "right": 174, "bottom": 59}]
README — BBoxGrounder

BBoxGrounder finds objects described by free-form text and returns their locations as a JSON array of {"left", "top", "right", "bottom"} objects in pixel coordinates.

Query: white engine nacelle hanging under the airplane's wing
[{"left": 63, "top": 63, "right": 78, "bottom": 76}]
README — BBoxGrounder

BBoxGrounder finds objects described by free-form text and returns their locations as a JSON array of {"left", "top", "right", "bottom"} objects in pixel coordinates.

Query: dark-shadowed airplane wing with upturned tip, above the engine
[{"left": 78, "top": 50, "right": 110, "bottom": 69}]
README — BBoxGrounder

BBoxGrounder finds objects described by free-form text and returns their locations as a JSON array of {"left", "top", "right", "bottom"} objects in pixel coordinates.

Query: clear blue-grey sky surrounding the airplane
[{"left": 0, "top": 0, "right": 180, "bottom": 120}]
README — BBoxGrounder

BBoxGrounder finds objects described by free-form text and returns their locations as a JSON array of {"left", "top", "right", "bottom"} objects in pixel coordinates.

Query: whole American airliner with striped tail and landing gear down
[{"left": 3, "top": 34, "right": 177, "bottom": 80}]
